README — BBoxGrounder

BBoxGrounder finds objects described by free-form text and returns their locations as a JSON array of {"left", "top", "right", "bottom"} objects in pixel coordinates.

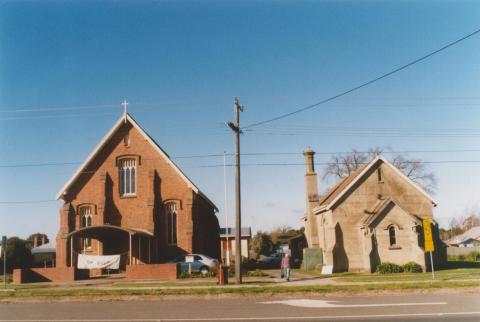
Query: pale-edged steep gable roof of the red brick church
[{"left": 56, "top": 113, "right": 218, "bottom": 211}]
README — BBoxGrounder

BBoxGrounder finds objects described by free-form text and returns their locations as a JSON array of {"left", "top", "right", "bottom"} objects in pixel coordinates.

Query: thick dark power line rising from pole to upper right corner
[{"left": 243, "top": 29, "right": 480, "bottom": 129}]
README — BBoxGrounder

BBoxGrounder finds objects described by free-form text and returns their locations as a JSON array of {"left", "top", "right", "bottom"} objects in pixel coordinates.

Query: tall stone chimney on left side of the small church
[{"left": 303, "top": 148, "right": 319, "bottom": 247}]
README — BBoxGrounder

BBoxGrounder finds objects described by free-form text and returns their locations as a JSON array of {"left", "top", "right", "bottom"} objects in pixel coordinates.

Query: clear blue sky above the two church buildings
[{"left": 0, "top": 1, "right": 480, "bottom": 242}]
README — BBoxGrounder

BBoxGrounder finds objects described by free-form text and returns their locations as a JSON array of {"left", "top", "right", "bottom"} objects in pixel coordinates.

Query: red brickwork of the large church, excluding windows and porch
[{"left": 57, "top": 122, "right": 220, "bottom": 267}]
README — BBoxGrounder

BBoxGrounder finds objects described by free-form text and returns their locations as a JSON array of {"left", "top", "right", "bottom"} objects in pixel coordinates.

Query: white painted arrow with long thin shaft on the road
[{"left": 260, "top": 299, "right": 448, "bottom": 308}]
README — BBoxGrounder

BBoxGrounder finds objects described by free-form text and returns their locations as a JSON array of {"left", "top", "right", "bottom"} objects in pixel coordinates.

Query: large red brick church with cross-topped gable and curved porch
[{"left": 56, "top": 113, "right": 220, "bottom": 270}]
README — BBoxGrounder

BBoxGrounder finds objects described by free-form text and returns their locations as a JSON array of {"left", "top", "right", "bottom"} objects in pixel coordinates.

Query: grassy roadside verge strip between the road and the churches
[{"left": 0, "top": 270, "right": 480, "bottom": 302}]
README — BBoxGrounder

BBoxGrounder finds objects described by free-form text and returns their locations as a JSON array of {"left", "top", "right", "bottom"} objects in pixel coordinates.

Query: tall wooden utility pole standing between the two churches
[{"left": 227, "top": 97, "right": 243, "bottom": 284}]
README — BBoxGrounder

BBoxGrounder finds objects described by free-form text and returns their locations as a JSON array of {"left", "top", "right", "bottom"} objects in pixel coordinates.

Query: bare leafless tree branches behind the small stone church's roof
[{"left": 322, "top": 147, "right": 437, "bottom": 193}]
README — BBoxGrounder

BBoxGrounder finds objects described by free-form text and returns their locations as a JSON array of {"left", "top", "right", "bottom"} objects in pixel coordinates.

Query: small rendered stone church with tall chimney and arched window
[{"left": 303, "top": 149, "right": 446, "bottom": 272}]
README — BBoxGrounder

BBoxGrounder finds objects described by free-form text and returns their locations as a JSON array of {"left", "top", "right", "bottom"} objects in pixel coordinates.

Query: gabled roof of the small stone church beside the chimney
[{"left": 314, "top": 155, "right": 437, "bottom": 212}]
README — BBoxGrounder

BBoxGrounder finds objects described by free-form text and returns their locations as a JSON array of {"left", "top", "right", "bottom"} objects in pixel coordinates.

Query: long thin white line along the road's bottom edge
[{"left": 0, "top": 311, "right": 480, "bottom": 322}]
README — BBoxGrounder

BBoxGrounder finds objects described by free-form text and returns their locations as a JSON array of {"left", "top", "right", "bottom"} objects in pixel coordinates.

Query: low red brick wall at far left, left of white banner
[{"left": 13, "top": 267, "right": 80, "bottom": 284}]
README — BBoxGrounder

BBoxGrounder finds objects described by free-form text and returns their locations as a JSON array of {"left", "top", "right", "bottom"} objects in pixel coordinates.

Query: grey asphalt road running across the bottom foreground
[{"left": 0, "top": 294, "right": 480, "bottom": 322}]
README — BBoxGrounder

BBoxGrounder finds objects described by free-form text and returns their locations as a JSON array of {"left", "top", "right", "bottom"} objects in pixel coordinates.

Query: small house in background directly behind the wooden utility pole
[{"left": 220, "top": 227, "right": 252, "bottom": 263}]
